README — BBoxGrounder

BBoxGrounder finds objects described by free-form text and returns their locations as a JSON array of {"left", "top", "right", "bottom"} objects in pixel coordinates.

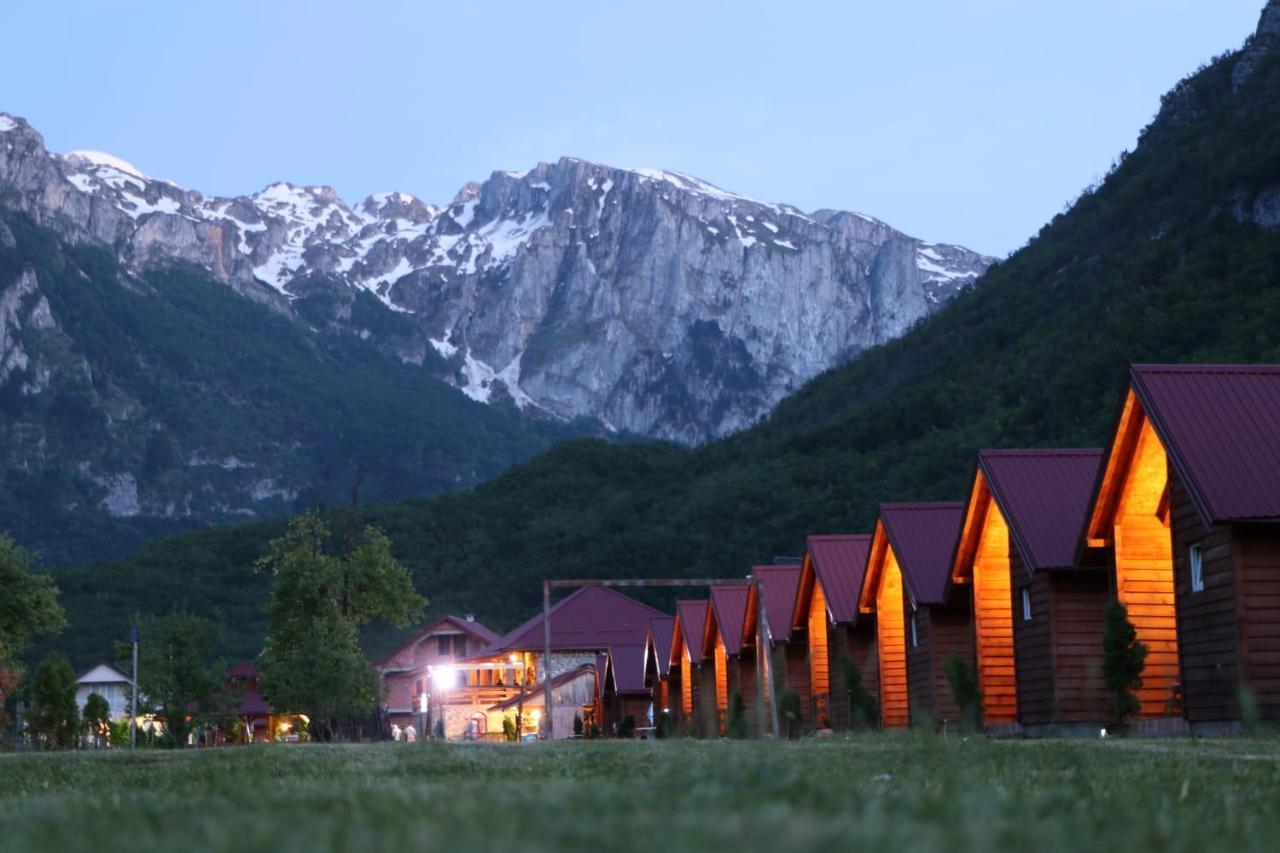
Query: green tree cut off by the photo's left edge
[{"left": 0, "top": 534, "right": 67, "bottom": 729}]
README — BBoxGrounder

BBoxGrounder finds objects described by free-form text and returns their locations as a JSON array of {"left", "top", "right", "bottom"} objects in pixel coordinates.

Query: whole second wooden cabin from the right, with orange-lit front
[{"left": 951, "top": 450, "right": 1111, "bottom": 734}]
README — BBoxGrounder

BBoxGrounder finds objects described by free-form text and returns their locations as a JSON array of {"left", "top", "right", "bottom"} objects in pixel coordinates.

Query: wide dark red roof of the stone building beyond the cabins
[{"left": 481, "top": 587, "right": 663, "bottom": 657}]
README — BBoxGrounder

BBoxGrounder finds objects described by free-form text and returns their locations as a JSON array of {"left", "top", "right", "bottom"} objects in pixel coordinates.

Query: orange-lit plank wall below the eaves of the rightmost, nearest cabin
[{"left": 1114, "top": 419, "right": 1179, "bottom": 717}]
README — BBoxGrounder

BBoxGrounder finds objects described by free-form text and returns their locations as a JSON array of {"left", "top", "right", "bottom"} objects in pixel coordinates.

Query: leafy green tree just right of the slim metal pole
[{"left": 116, "top": 611, "right": 221, "bottom": 747}]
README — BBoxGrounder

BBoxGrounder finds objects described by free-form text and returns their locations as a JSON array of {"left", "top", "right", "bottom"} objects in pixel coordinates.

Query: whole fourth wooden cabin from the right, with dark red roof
[{"left": 795, "top": 534, "right": 879, "bottom": 729}]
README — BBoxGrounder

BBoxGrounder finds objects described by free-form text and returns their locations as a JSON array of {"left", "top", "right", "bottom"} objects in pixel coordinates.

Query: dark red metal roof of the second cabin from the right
[{"left": 978, "top": 448, "right": 1102, "bottom": 571}]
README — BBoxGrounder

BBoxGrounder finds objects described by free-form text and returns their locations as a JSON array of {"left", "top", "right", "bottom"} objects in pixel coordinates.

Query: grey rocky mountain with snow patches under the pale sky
[{"left": 0, "top": 114, "right": 991, "bottom": 443}]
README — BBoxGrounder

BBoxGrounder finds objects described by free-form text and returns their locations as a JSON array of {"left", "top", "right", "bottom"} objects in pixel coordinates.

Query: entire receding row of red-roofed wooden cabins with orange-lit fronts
[{"left": 384, "top": 365, "right": 1280, "bottom": 734}]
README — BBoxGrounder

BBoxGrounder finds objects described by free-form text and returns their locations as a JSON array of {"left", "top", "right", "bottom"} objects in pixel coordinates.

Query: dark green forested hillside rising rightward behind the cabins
[{"left": 35, "top": 9, "right": 1280, "bottom": 661}]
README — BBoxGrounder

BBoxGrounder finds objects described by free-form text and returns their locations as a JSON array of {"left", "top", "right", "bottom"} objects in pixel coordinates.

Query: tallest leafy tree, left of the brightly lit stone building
[{"left": 259, "top": 511, "right": 426, "bottom": 738}]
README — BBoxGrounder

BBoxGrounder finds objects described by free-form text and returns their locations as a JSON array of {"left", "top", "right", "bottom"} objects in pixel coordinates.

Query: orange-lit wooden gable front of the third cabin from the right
[{"left": 860, "top": 525, "right": 910, "bottom": 729}]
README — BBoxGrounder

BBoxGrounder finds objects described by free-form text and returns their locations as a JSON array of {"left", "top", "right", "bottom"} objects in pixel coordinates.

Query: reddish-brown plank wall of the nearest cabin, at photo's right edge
[{"left": 1233, "top": 525, "right": 1280, "bottom": 720}]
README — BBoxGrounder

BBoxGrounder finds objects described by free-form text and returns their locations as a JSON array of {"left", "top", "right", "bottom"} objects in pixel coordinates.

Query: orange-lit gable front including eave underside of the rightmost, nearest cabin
[{"left": 1089, "top": 391, "right": 1180, "bottom": 717}]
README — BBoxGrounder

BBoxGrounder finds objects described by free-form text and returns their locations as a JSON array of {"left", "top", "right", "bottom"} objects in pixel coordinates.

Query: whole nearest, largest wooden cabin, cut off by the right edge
[{"left": 1085, "top": 365, "right": 1280, "bottom": 730}]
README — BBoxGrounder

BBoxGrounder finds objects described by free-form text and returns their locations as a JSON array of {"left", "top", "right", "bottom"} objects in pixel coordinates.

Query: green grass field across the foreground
[{"left": 0, "top": 735, "right": 1280, "bottom": 853}]
